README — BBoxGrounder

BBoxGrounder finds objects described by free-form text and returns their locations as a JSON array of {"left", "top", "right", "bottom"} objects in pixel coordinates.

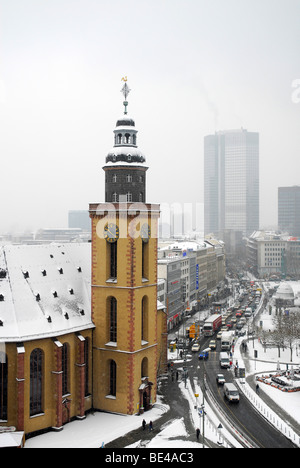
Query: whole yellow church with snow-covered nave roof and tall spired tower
[{"left": 0, "top": 81, "right": 167, "bottom": 440}]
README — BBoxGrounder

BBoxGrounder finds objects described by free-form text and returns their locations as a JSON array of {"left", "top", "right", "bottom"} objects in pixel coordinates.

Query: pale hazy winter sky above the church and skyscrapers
[{"left": 0, "top": 0, "right": 300, "bottom": 232}]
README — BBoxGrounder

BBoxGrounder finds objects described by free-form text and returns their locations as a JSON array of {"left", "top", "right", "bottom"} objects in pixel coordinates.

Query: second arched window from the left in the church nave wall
[{"left": 30, "top": 348, "right": 44, "bottom": 416}]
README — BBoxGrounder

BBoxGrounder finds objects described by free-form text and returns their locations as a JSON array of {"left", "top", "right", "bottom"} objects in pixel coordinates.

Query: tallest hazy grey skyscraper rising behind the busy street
[{"left": 204, "top": 129, "right": 259, "bottom": 235}]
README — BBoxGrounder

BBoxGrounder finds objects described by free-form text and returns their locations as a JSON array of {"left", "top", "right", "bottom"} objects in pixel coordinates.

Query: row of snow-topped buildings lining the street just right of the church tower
[{"left": 158, "top": 237, "right": 225, "bottom": 329}]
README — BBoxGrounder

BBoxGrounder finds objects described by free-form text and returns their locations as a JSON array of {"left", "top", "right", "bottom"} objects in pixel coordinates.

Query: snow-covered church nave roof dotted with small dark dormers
[{"left": 0, "top": 243, "right": 94, "bottom": 342}]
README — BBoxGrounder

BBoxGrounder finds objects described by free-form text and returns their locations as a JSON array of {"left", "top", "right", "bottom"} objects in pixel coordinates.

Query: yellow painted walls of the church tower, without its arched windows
[{"left": 92, "top": 205, "right": 162, "bottom": 414}]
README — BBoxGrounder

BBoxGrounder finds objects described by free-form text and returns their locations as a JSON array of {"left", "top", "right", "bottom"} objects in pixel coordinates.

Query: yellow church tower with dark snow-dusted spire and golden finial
[{"left": 89, "top": 81, "right": 161, "bottom": 414}]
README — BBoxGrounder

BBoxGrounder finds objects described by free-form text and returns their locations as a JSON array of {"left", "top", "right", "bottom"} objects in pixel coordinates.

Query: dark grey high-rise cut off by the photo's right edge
[{"left": 278, "top": 186, "right": 300, "bottom": 237}]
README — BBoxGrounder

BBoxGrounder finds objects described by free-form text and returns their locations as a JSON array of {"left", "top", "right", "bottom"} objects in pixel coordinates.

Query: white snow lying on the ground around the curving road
[{"left": 25, "top": 283, "right": 300, "bottom": 449}]
